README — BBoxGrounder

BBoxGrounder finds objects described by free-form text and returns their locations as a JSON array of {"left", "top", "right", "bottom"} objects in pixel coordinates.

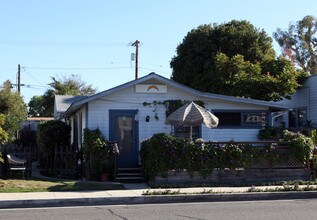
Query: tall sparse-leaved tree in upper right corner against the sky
[{"left": 273, "top": 15, "right": 317, "bottom": 74}]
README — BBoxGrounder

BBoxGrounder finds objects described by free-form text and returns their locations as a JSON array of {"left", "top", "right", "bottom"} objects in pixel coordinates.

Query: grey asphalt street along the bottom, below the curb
[{"left": 0, "top": 199, "right": 317, "bottom": 220}]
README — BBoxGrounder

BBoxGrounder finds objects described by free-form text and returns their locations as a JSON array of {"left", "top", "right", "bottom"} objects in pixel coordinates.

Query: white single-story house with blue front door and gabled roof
[{"left": 55, "top": 73, "right": 289, "bottom": 167}]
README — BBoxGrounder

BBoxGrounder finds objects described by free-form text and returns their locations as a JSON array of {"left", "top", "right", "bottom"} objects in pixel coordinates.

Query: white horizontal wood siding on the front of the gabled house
[{"left": 85, "top": 84, "right": 268, "bottom": 148}]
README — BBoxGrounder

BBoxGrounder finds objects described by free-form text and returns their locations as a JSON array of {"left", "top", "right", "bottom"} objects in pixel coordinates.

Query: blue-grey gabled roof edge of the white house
[{"left": 66, "top": 73, "right": 288, "bottom": 114}]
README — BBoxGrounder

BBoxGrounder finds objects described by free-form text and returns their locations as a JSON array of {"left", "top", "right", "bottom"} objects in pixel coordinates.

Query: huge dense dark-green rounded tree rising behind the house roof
[{"left": 171, "top": 20, "right": 302, "bottom": 100}]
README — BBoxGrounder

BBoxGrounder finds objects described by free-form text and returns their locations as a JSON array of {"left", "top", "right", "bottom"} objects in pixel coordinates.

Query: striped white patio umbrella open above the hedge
[{"left": 166, "top": 102, "right": 219, "bottom": 139}]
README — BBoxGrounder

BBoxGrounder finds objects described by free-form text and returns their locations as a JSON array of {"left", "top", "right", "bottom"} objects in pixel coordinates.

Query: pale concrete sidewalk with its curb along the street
[{"left": 0, "top": 184, "right": 317, "bottom": 208}]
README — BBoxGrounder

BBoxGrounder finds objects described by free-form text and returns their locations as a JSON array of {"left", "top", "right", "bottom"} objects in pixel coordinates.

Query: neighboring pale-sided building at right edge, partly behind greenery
[{"left": 278, "top": 75, "right": 317, "bottom": 129}]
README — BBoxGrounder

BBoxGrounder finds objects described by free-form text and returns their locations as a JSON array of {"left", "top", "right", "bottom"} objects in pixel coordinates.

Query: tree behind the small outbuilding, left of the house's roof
[{"left": 29, "top": 75, "right": 96, "bottom": 117}]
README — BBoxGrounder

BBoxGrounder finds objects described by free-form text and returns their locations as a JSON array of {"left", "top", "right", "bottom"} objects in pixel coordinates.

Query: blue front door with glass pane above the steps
[{"left": 109, "top": 110, "right": 139, "bottom": 168}]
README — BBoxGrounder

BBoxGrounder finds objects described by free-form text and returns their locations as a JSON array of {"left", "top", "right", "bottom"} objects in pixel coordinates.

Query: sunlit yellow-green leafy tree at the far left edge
[{"left": 0, "top": 81, "right": 27, "bottom": 141}]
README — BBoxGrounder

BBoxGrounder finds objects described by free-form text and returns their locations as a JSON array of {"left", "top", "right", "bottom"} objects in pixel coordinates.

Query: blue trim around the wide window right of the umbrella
[{"left": 210, "top": 109, "right": 271, "bottom": 129}]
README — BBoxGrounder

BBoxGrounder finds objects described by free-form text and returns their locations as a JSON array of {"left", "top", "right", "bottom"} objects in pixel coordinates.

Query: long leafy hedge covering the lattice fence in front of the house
[{"left": 140, "top": 131, "right": 314, "bottom": 180}]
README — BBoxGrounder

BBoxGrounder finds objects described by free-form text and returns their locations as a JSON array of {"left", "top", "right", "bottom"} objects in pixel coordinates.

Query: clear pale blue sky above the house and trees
[{"left": 0, "top": 0, "right": 317, "bottom": 102}]
